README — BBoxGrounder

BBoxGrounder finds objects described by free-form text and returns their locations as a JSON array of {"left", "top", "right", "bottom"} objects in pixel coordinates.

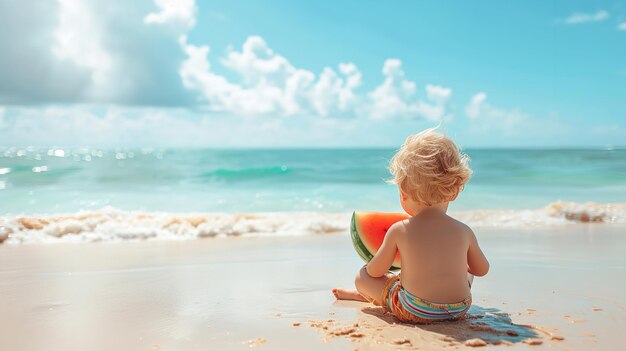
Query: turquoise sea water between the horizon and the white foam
[{"left": 0, "top": 148, "right": 626, "bottom": 215}]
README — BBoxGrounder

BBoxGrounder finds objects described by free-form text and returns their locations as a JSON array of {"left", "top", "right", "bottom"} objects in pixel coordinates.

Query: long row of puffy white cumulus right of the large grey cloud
[{"left": 180, "top": 36, "right": 452, "bottom": 120}]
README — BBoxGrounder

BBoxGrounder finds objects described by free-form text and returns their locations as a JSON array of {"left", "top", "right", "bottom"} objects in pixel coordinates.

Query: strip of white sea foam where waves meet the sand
[{"left": 0, "top": 202, "right": 626, "bottom": 244}]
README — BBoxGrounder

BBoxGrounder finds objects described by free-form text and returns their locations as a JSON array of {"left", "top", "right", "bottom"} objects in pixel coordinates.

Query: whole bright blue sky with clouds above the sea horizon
[{"left": 0, "top": 0, "right": 626, "bottom": 148}]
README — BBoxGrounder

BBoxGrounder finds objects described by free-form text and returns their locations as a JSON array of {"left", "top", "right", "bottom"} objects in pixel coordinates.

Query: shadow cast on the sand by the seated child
[{"left": 361, "top": 305, "right": 549, "bottom": 345}]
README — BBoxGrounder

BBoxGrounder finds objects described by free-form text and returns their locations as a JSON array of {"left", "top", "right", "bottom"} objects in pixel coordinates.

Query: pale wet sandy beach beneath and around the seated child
[{"left": 0, "top": 224, "right": 626, "bottom": 350}]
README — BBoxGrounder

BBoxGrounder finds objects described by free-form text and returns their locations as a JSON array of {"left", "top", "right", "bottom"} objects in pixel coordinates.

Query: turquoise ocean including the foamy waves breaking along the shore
[{"left": 0, "top": 147, "right": 626, "bottom": 241}]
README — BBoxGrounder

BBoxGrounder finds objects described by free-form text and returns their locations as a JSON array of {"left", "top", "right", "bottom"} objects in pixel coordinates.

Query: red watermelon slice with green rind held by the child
[{"left": 350, "top": 211, "right": 409, "bottom": 270}]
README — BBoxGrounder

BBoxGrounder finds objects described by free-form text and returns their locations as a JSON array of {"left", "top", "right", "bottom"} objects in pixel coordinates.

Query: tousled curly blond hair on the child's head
[{"left": 389, "top": 128, "right": 472, "bottom": 206}]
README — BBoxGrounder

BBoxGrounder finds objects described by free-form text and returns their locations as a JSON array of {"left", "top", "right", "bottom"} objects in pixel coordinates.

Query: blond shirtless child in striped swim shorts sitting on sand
[{"left": 333, "top": 129, "right": 489, "bottom": 323}]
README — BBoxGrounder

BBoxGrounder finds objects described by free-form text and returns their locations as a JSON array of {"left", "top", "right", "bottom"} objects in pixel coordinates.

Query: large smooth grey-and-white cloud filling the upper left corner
[{"left": 0, "top": 0, "right": 193, "bottom": 105}]
